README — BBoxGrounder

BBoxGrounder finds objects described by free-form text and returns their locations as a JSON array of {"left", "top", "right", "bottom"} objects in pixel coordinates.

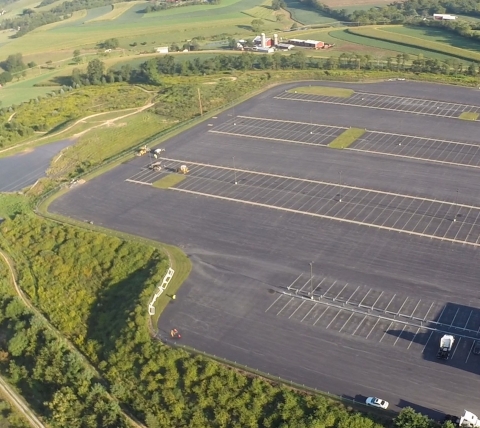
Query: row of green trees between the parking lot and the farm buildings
[{"left": 72, "top": 50, "right": 479, "bottom": 86}]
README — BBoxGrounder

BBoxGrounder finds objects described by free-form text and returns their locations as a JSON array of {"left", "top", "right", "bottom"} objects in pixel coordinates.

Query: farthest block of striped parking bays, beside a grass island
[{"left": 275, "top": 91, "right": 480, "bottom": 118}]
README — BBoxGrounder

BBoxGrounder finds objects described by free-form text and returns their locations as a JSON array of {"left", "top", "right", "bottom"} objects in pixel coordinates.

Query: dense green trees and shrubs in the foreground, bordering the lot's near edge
[{"left": 0, "top": 213, "right": 453, "bottom": 428}]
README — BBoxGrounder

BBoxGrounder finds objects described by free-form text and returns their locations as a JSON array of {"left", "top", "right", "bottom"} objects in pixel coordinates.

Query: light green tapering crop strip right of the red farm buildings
[{"left": 348, "top": 26, "right": 480, "bottom": 62}]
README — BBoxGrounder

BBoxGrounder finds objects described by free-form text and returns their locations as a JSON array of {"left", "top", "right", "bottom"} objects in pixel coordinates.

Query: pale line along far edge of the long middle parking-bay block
[{"left": 160, "top": 157, "right": 480, "bottom": 210}]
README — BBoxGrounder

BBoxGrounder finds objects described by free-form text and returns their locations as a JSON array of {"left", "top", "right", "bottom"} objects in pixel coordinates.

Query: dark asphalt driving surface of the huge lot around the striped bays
[{"left": 51, "top": 82, "right": 480, "bottom": 416}]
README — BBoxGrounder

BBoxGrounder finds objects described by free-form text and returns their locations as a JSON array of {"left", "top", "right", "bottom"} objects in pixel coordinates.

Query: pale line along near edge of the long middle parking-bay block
[{"left": 169, "top": 187, "right": 480, "bottom": 247}]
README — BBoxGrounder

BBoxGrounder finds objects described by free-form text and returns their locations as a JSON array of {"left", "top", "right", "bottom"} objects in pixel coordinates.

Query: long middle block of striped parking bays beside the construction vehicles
[{"left": 127, "top": 159, "right": 480, "bottom": 247}]
